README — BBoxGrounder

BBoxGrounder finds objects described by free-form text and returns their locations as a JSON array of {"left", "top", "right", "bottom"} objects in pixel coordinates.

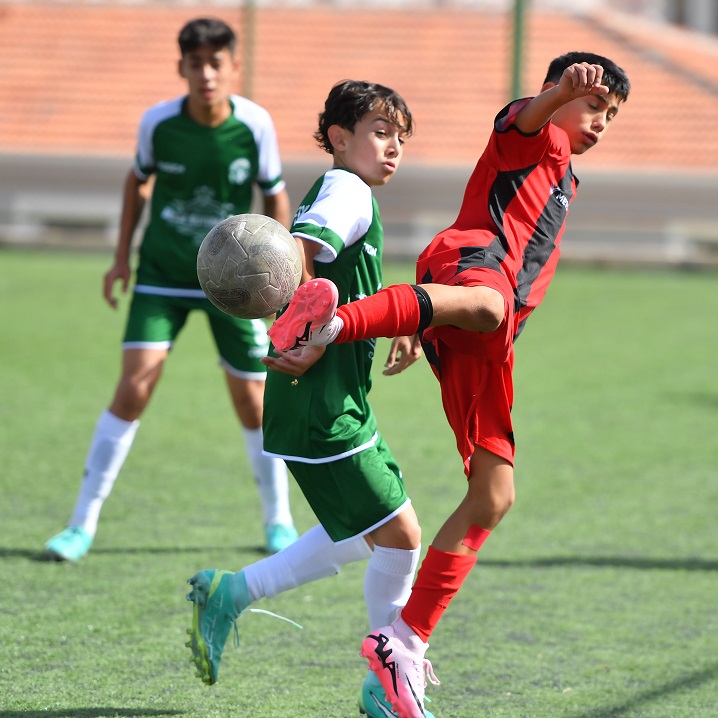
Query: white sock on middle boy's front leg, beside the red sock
[{"left": 364, "top": 545, "right": 421, "bottom": 631}]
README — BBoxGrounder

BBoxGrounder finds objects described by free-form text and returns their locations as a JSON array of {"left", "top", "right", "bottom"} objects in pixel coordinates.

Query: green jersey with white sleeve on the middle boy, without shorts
[{"left": 264, "top": 169, "right": 384, "bottom": 463}]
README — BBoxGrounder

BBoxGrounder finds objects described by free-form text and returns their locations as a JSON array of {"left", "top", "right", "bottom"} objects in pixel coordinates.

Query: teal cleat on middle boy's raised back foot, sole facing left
[{"left": 185, "top": 569, "right": 251, "bottom": 686}]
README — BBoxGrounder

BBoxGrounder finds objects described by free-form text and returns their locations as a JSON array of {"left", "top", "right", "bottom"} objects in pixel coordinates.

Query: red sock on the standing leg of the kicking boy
[{"left": 401, "top": 546, "right": 476, "bottom": 643}]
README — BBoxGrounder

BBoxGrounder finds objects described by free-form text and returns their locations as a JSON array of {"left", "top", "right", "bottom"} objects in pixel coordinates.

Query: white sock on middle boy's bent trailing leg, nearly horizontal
[{"left": 244, "top": 526, "right": 371, "bottom": 601}]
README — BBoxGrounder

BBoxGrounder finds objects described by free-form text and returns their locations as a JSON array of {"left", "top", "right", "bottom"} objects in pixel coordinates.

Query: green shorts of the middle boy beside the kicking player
[{"left": 287, "top": 435, "right": 409, "bottom": 542}]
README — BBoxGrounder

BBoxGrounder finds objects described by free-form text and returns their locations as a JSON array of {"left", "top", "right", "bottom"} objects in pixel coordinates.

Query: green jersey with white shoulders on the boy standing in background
[{"left": 135, "top": 95, "right": 284, "bottom": 296}]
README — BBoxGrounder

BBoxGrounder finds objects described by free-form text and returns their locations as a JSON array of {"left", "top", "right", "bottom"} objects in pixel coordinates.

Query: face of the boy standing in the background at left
[{"left": 179, "top": 46, "right": 239, "bottom": 107}]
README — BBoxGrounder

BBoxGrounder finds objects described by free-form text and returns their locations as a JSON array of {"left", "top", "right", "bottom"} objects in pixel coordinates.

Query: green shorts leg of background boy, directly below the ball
[{"left": 205, "top": 301, "right": 269, "bottom": 380}]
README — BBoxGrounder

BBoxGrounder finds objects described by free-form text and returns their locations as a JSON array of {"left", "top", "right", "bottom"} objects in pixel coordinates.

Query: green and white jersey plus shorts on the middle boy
[{"left": 264, "top": 169, "right": 408, "bottom": 541}]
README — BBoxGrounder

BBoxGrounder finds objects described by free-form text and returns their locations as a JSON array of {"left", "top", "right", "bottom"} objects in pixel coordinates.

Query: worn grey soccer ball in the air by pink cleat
[{"left": 197, "top": 214, "right": 302, "bottom": 319}]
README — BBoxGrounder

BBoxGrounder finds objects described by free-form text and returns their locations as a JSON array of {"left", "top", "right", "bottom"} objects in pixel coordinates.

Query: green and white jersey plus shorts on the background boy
[{"left": 123, "top": 95, "right": 284, "bottom": 380}]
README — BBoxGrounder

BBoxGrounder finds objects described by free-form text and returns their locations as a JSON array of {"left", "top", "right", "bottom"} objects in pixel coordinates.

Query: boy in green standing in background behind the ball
[{"left": 46, "top": 18, "right": 296, "bottom": 561}]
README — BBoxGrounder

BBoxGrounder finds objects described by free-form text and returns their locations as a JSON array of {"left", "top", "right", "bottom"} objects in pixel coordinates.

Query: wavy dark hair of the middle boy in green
[{"left": 314, "top": 80, "right": 414, "bottom": 154}]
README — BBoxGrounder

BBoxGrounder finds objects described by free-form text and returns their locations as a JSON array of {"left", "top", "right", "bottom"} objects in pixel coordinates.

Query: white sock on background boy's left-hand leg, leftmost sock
[{"left": 69, "top": 411, "right": 140, "bottom": 536}]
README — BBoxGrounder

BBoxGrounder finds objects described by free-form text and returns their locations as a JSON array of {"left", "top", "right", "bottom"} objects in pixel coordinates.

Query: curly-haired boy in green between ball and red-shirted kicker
[{"left": 187, "top": 81, "right": 434, "bottom": 718}]
